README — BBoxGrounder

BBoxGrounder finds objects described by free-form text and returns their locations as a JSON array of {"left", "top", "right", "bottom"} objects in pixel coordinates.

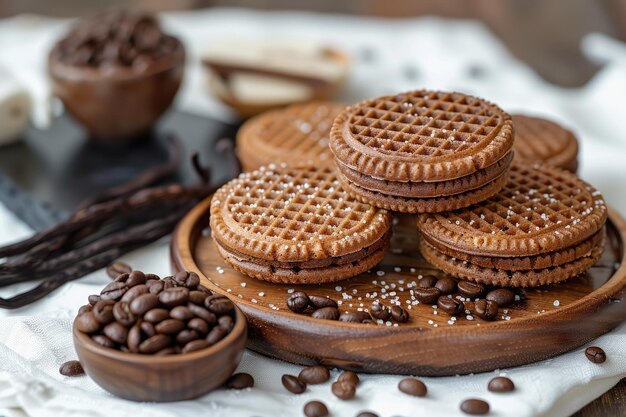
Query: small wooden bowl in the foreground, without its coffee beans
[{"left": 73, "top": 308, "right": 247, "bottom": 402}]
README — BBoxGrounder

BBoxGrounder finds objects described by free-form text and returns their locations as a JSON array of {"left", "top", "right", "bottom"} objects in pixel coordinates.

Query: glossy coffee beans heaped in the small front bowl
[{"left": 75, "top": 271, "right": 235, "bottom": 355}]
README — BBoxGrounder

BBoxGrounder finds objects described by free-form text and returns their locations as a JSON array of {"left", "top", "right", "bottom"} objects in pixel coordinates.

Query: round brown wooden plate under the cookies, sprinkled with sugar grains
[{"left": 171, "top": 199, "right": 626, "bottom": 376}]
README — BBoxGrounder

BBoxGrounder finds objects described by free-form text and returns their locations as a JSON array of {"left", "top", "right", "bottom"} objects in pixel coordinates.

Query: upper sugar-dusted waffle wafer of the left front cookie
[{"left": 210, "top": 162, "right": 391, "bottom": 262}]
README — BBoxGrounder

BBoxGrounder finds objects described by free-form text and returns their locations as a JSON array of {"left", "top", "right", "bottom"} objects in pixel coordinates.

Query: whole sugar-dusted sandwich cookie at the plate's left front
[{"left": 210, "top": 164, "right": 391, "bottom": 284}]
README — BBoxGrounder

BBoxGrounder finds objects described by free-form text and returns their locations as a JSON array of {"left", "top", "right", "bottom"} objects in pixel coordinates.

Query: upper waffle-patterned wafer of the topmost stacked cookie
[{"left": 330, "top": 90, "right": 513, "bottom": 182}]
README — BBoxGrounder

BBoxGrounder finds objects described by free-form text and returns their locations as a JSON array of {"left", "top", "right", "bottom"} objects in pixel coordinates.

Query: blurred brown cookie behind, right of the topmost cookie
[{"left": 513, "top": 115, "right": 578, "bottom": 172}]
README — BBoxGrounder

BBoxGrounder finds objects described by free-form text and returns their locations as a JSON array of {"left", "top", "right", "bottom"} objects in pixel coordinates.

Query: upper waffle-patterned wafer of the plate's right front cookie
[{"left": 417, "top": 162, "right": 607, "bottom": 257}]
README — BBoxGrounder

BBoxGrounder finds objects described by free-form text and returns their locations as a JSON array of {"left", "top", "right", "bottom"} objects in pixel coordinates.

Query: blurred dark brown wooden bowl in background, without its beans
[{"left": 48, "top": 41, "right": 185, "bottom": 142}]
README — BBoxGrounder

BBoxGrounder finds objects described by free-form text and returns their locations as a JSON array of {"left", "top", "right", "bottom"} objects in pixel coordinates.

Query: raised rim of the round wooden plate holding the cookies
[{"left": 170, "top": 195, "right": 626, "bottom": 336}]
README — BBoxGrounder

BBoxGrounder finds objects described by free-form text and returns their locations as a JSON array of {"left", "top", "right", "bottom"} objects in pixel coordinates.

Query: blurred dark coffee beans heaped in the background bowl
[{"left": 52, "top": 11, "right": 180, "bottom": 70}]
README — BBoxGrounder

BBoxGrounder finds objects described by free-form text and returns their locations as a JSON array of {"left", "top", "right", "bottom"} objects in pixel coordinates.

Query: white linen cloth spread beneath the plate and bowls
[{"left": 0, "top": 10, "right": 626, "bottom": 417}]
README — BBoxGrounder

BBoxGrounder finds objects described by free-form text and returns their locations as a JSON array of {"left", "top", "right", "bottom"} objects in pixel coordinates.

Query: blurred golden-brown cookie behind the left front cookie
[{"left": 236, "top": 101, "right": 346, "bottom": 171}]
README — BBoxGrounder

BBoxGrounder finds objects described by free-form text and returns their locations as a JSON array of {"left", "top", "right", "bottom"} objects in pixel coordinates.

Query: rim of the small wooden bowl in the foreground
[{"left": 72, "top": 303, "right": 248, "bottom": 365}]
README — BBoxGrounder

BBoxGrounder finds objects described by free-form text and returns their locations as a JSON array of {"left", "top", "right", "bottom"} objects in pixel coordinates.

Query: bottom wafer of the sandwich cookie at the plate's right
[{"left": 420, "top": 239, "right": 604, "bottom": 287}]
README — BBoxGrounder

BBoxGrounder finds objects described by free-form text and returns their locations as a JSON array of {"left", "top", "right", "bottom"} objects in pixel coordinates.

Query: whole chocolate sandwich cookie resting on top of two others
[{"left": 330, "top": 90, "right": 513, "bottom": 213}]
